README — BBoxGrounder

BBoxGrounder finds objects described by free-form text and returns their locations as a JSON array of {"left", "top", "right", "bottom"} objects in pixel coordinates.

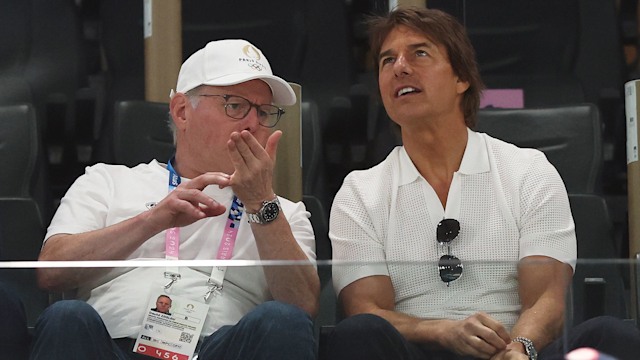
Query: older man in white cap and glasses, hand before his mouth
[{"left": 32, "top": 40, "right": 319, "bottom": 359}]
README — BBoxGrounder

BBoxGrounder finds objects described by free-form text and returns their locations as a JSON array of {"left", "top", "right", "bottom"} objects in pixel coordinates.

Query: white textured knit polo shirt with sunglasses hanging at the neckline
[{"left": 329, "top": 130, "right": 577, "bottom": 329}]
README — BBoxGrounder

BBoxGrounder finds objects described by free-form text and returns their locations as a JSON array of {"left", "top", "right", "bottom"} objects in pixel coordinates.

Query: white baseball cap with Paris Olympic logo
[{"left": 169, "top": 39, "right": 296, "bottom": 105}]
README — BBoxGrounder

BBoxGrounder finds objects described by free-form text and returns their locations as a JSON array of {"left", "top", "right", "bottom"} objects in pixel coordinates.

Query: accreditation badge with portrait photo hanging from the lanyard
[{"left": 133, "top": 286, "right": 209, "bottom": 360}]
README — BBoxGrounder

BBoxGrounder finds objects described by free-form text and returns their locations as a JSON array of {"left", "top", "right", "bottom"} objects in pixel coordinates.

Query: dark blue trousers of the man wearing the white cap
[{"left": 31, "top": 300, "right": 315, "bottom": 360}]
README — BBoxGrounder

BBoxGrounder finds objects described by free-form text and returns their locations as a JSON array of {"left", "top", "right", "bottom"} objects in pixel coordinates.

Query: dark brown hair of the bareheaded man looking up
[{"left": 367, "top": 6, "right": 484, "bottom": 129}]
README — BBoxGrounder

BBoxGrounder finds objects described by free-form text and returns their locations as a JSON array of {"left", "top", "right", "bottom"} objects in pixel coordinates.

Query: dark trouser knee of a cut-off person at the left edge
[{"left": 0, "top": 283, "right": 30, "bottom": 360}]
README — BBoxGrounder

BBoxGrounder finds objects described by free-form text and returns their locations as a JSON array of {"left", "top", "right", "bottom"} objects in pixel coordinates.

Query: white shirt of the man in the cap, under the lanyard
[{"left": 45, "top": 160, "right": 315, "bottom": 338}]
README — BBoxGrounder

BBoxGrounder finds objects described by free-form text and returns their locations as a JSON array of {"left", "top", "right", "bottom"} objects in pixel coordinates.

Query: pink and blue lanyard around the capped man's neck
[{"left": 164, "top": 158, "right": 244, "bottom": 301}]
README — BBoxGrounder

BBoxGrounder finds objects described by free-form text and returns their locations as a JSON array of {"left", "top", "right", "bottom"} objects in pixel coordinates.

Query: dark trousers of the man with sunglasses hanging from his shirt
[{"left": 327, "top": 314, "right": 640, "bottom": 360}]
